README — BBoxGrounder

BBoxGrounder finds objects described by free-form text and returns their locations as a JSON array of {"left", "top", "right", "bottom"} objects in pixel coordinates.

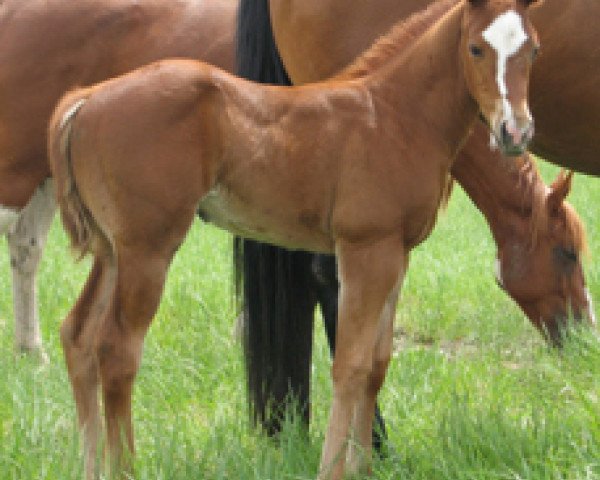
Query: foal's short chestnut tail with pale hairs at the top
[{"left": 48, "top": 89, "right": 97, "bottom": 258}]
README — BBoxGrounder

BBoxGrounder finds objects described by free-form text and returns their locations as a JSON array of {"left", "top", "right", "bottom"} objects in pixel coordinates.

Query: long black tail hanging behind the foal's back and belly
[{"left": 234, "top": 0, "right": 316, "bottom": 435}]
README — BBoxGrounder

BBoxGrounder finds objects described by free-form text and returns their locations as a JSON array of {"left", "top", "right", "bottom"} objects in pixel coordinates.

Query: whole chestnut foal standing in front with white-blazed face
[{"left": 48, "top": 0, "right": 537, "bottom": 480}]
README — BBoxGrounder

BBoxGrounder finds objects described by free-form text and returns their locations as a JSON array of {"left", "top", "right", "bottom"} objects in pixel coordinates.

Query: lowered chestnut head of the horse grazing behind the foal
[{"left": 496, "top": 173, "right": 596, "bottom": 346}]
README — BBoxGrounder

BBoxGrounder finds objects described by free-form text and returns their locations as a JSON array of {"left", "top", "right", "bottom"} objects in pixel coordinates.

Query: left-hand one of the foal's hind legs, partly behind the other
[{"left": 60, "top": 259, "right": 115, "bottom": 480}]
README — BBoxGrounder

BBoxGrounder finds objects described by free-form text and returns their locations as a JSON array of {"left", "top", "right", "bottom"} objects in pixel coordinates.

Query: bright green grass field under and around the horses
[{"left": 0, "top": 166, "right": 600, "bottom": 480}]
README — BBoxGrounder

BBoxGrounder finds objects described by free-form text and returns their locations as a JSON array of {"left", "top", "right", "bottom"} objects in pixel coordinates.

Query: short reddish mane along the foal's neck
[{"left": 334, "top": 0, "right": 460, "bottom": 80}]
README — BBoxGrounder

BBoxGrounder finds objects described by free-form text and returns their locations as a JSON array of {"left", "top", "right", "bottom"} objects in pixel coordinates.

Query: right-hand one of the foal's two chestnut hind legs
[{"left": 95, "top": 247, "right": 171, "bottom": 475}]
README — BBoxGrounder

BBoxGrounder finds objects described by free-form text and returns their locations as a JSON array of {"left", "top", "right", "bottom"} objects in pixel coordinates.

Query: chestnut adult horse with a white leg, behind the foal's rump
[{"left": 0, "top": 0, "right": 237, "bottom": 351}]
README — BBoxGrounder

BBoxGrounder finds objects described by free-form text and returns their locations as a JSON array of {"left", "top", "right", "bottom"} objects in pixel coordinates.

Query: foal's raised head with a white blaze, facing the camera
[{"left": 461, "top": 0, "right": 538, "bottom": 156}]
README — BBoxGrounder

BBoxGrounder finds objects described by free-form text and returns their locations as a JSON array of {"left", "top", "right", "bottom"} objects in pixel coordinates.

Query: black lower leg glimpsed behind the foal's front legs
[{"left": 312, "top": 254, "right": 387, "bottom": 454}]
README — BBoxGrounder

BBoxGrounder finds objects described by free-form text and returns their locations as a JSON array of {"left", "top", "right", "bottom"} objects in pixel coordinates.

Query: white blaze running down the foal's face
[{"left": 482, "top": 10, "right": 528, "bottom": 127}]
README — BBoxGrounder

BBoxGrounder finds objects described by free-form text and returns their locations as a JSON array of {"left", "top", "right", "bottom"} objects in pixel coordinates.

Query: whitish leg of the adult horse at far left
[{"left": 8, "top": 179, "right": 56, "bottom": 358}]
